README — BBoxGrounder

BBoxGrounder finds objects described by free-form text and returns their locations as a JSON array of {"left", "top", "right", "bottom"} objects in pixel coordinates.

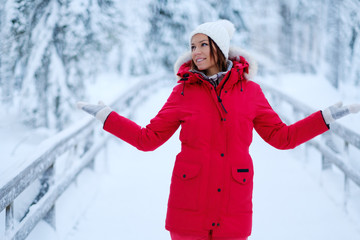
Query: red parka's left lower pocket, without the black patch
[{"left": 168, "top": 161, "right": 201, "bottom": 210}]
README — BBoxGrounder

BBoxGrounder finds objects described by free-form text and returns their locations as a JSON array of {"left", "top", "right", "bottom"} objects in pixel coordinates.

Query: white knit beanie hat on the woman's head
[{"left": 190, "top": 20, "right": 235, "bottom": 59}]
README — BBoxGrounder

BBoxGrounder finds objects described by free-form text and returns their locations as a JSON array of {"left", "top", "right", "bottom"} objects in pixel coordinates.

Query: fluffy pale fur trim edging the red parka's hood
[{"left": 174, "top": 47, "right": 258, "bottom": 80}]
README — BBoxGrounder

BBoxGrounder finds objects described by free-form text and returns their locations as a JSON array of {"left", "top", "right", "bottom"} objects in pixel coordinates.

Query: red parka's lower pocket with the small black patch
[{"left": 228, "top": 166, "right": 253, "bottom": 215}]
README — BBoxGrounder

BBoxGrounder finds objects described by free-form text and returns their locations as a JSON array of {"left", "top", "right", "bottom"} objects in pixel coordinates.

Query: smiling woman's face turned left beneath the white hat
[{"left": 191, "top": 33, "right": 219, "bottom": 76}]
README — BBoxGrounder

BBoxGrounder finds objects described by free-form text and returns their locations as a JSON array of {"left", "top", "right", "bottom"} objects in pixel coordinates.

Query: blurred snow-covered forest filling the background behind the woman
[{"left": 0, "top": 0, "right": 360, "bottom": 130}]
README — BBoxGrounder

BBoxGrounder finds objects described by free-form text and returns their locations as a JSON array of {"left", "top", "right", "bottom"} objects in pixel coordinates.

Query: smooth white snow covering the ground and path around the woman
[{"left": 0, "top": 70, "right": 360, "bottom": 240}]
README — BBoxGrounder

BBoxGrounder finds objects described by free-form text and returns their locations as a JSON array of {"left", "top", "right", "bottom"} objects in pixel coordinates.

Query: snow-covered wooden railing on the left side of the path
[{"left": 0, "top": 73, "right": 168, "bottom": 240}]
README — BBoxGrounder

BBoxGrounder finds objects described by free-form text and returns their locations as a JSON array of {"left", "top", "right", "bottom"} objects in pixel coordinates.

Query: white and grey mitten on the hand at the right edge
[{"left": 322, "top": 102, "right": 360, "bottom": 124}]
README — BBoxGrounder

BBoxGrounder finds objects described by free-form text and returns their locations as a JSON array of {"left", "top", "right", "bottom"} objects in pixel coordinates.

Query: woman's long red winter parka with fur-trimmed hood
[{"left": 104, "top": 48, "right": 328, "bottom": 237}]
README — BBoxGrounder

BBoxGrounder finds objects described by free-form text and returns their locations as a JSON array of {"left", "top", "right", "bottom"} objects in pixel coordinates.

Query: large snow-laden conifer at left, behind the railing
[{"left": 0, "top": 0, "right": 126, "bottom": 129}]
